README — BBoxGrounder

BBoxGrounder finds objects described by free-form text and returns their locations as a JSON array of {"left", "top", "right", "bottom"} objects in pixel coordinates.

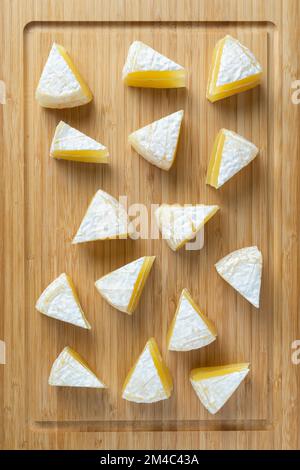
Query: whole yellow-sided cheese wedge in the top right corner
[{"left": 206, "top": 35, "right": 262, "bottom": 103}]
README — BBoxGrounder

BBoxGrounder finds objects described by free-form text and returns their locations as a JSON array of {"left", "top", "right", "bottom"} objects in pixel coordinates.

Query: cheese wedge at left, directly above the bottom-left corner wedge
[{"left": 35, "top": 273, "right": 91, "bottom": 330}]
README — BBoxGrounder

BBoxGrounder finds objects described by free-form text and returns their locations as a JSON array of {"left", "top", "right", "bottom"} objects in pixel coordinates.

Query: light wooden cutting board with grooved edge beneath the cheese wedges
[{"left": 0, "top": 0, "right": 300, "bottom": 449}]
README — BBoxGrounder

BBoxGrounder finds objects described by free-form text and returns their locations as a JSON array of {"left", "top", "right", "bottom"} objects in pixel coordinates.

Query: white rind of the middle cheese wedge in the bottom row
[{"left": 122, "top": 345, "right": 169, "bottom": 403}]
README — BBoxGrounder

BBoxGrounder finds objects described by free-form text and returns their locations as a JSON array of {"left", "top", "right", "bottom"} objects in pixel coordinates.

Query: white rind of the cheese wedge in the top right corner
[{"left": 216, "top": 36, "right": 262, "bottom": 86}]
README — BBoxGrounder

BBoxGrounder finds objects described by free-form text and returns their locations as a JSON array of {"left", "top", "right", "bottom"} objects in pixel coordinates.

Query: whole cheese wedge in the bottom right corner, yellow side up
[{"left": 190, "top": 363, "right": 249, "bottom": 414}]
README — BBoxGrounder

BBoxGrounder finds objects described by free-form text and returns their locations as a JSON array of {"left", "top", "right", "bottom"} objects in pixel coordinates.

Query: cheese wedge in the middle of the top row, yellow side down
[{"left": 122, "top": 41, "right": 186, "bottom": 88}]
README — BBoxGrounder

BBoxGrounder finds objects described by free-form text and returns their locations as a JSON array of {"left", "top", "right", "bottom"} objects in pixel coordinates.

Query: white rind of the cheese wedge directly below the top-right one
[{"left": 218, "top": 129, "right": 258, "bottom": 188}]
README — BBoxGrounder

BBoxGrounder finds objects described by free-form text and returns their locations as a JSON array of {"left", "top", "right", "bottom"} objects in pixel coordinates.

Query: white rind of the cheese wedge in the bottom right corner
[{"left": 191, "top": 369, "right": 249, "bottom": 414}]
